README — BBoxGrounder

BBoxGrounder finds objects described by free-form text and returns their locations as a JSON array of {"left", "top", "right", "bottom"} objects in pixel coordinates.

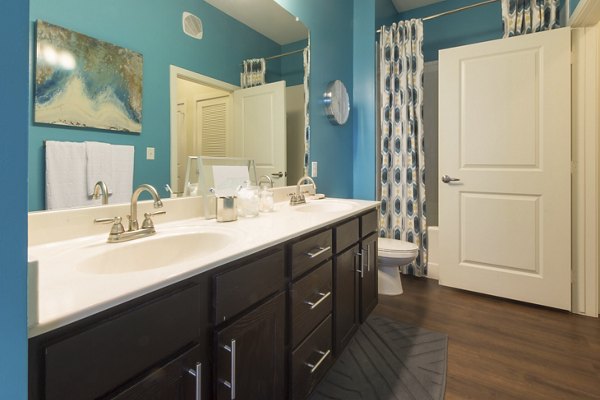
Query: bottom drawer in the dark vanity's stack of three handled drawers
[{"left": 291, "top": 317, "right": 333, "bottom": 400}]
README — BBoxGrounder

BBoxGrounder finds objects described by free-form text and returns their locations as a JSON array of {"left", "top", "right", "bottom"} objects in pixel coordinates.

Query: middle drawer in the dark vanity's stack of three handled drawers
[{"left": 291, "top": 261, "right": 332, "bottom": 348}]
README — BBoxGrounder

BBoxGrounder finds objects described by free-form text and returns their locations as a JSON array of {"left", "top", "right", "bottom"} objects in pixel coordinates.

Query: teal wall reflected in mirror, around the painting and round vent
[{"left": 29, "top": 0, "right": 281, "bottom": 210}]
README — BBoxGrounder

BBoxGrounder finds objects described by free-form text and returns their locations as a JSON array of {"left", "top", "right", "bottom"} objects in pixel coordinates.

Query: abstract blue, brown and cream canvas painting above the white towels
[{"left": 34, "top": 20, "right": 143, "bottom": 133}]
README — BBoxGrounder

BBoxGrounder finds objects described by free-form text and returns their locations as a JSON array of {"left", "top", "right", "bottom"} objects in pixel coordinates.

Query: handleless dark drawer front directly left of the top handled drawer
[{"left": 215, "top": 249, "right": 284, "bottom": 324}]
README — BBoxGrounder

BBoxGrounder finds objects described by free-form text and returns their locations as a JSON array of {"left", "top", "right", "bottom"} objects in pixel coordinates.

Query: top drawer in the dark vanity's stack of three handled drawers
[{"left": 292, "top": 230, "right": 333, "bottom": 278}]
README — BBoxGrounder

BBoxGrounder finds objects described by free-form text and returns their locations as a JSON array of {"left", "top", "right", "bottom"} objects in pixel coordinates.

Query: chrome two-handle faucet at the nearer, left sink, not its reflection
[{"left": 94, "top": 184, "right": 166, "bottom": 243}]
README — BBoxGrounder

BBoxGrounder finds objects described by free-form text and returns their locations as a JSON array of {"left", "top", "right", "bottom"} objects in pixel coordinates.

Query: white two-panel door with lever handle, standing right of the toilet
[{"left": 439, "top": 29, "right": 571, "bottom": 310}]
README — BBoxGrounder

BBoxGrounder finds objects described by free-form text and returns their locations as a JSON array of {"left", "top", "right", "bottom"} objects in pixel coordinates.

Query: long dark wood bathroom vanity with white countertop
[{"left": 29, "top": 200, "right": 378, "bottom": 400}]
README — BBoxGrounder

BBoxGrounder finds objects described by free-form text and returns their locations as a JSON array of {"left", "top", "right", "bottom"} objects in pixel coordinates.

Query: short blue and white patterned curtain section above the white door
[{"left": 502, "top": 0, "right": 560, "bottom": 38}]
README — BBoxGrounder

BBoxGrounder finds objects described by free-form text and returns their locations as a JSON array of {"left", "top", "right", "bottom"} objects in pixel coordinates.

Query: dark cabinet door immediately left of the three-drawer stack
[{"left": 215, "top": 293, "right": 285, "bottom": 400}]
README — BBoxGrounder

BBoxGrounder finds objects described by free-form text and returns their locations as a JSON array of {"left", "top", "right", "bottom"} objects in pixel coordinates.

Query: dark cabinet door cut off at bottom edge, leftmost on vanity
[{"left": 109, "top": 345, "right": 208, "bottom": 400}]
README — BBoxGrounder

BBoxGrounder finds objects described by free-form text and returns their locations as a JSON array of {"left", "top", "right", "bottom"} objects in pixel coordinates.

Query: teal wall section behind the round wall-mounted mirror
[{"left": 276, "top": 0, "right": 356, "bottom": 197}]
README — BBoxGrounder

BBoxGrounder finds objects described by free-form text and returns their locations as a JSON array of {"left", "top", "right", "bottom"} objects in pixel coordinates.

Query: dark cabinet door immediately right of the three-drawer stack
[{"left": 334, "top": 246, "right": 360, "bottom": 354}]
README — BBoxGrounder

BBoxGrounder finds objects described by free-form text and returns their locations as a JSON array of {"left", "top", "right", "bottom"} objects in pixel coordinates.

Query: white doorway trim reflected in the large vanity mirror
[{"left": 169, "top": 65, "right": 240, "bottom": 189}]
